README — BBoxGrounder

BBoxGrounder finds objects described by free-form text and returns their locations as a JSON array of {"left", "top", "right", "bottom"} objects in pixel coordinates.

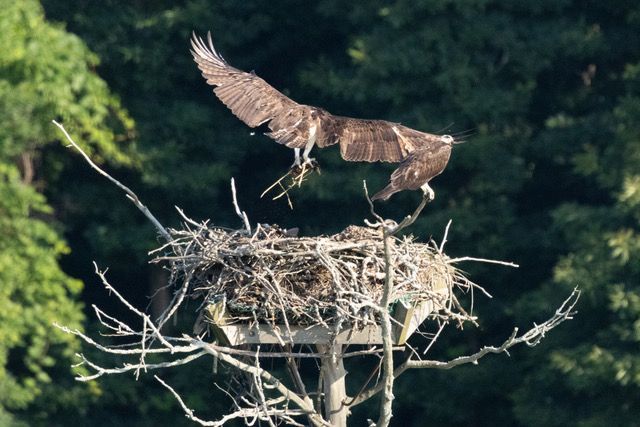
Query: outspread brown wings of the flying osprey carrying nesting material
[{"left": 191, "top": 33, "right": 428, "bottom": 162}]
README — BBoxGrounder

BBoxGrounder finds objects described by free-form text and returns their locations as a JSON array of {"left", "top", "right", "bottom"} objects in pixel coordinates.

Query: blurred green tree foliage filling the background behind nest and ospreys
[{"left": 0, "top": 0, "right": 640, "bottom": 426}]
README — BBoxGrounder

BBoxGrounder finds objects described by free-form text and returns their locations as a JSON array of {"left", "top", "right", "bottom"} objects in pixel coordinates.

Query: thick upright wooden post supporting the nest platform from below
[{"left": 318, "top": 343, "right": 349, "bottom": 427}]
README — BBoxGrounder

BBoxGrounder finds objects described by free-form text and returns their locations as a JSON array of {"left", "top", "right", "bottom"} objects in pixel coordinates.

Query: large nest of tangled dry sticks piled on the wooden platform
[{"left": 155, "top": 223, "right": 466, "bottom": 328}]
